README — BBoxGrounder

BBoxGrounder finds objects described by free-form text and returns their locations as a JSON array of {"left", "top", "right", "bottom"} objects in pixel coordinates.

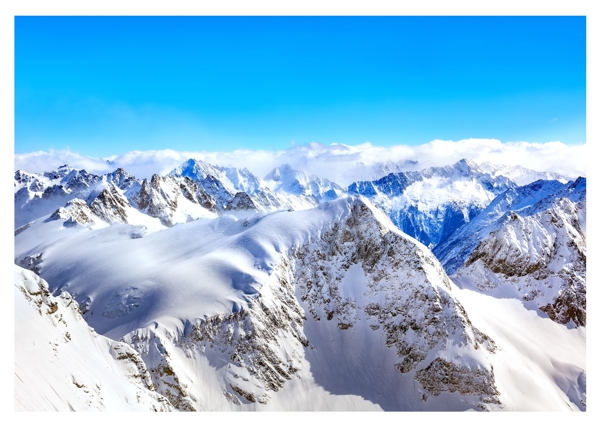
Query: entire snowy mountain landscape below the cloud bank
[{"left": 14, "top": 155, "right": 586, "bottom": 411}]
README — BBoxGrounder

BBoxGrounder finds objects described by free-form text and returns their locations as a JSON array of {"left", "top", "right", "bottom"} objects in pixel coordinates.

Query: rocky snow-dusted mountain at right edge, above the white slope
[{"left": 435, "top": 177, "right": 586, "bottom": 325}]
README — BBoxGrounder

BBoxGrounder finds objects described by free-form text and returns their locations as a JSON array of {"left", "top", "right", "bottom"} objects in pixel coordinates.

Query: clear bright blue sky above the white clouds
[{"left": 15, "top": 17, "right": 586, "bottom": 156}]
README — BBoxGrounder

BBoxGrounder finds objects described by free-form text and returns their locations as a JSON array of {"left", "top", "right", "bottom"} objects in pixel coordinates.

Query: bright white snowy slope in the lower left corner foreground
[{"left": 14, "top": 266, "right": 173, "bottom": 411}]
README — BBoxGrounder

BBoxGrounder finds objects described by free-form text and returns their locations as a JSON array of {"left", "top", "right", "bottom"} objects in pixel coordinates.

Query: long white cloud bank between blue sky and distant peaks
[{"left": 15, "top": 139, "right": 587, "bottom": 186}]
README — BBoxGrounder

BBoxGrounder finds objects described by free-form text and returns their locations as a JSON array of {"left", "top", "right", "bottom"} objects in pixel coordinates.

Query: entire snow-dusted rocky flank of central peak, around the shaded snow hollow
[{"left": 118, "top": 200, "right": 499, "bottom": 410}]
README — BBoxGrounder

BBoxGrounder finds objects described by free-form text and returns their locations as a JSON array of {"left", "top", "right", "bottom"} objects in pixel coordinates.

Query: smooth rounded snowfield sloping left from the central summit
[{"left": 16, "top": 204, "right": 356, "bottom": 338}]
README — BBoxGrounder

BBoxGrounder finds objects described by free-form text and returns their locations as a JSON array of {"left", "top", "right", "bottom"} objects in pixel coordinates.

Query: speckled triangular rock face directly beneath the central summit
[{"left": 295, "top": 201, "right": 497, "bottom": 402}]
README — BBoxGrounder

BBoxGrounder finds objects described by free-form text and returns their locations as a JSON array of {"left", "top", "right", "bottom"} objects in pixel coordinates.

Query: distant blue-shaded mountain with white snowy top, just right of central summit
[{"left": 348, "top": 159, "right": 516, "bottom": 248}]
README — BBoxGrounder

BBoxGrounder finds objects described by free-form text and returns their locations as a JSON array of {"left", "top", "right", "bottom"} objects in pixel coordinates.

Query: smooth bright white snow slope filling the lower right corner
[{"left": 457, "top": 288, "right": 587, "bottom": 411}]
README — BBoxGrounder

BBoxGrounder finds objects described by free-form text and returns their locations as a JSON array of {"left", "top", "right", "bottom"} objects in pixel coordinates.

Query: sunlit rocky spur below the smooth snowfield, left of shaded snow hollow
[{"left": 123, "top": 258, "right": 308, "bottom": 411}]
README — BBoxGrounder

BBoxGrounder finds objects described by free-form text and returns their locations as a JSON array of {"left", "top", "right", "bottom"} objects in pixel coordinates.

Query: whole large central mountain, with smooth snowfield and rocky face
[{"left": 15, "top": 198, "right": 501, "bottom": 410}]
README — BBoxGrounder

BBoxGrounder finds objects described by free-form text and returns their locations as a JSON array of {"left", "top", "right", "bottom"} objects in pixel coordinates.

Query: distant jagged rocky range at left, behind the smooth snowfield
[{"left": 14, "top": 160, "right": 318, "bottom": 229}]
